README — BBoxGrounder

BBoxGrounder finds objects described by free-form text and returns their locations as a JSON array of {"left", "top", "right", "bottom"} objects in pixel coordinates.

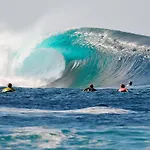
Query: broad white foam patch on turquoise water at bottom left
[{"left": 9, "top": 126, "right": 66, "bottom": 149}]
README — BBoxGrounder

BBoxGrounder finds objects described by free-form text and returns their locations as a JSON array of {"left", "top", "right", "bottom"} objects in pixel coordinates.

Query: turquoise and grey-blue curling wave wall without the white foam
[{"left": 37, "top": 28, "right": 150, "bottom": 87}]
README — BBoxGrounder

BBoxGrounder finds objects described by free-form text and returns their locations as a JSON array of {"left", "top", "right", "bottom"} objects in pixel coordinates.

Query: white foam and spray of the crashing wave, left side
[{"left": 0, "top": 23, "right": 65, "bottom": 87}]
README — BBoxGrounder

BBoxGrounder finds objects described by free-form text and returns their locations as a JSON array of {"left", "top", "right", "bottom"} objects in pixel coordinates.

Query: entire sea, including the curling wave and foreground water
[{"left": 0, "top": 28, "right": 150, "bottom": 150}]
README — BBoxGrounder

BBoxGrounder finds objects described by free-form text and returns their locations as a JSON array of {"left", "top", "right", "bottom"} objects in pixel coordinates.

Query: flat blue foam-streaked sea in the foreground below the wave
[{"left": 0, "top": 87, "right": 150, "bottom": 150}]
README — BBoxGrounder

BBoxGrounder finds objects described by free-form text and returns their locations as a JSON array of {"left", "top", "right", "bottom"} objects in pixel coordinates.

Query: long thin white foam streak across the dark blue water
[{"left": 0, "top": 107, "right": 132, "bottom": 116}]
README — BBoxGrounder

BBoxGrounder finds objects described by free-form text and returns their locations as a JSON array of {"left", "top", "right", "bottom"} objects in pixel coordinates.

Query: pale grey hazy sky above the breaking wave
[{"left": 0, "top": 0, "right": 150, "bottom": 36}]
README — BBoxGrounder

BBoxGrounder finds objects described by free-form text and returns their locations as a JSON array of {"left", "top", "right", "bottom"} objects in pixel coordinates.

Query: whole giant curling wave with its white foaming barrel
[{"left": 0, "top": 28, "right": 150, "bottom": 88}]
